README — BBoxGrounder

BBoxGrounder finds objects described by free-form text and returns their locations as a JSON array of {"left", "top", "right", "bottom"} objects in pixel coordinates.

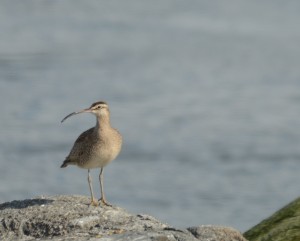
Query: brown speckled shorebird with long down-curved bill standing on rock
[{"left": 61, "top": 101, "right": 122, "bottom": 206}]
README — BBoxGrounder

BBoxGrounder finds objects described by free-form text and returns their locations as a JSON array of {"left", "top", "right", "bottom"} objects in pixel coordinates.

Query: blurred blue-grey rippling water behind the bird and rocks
[{"left": 0, "top": 0, "right": 300, "bottom": 231}]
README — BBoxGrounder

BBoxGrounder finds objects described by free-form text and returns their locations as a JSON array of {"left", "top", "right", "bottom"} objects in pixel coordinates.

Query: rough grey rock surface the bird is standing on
[{"left": 0, "top": 196, "right": 246, "bottom": 241}]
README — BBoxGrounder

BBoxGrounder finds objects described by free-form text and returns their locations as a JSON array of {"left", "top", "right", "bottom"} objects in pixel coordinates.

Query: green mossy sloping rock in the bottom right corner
[{"left": 244, "top": 198, "right": 300, "bottom": 241}]
